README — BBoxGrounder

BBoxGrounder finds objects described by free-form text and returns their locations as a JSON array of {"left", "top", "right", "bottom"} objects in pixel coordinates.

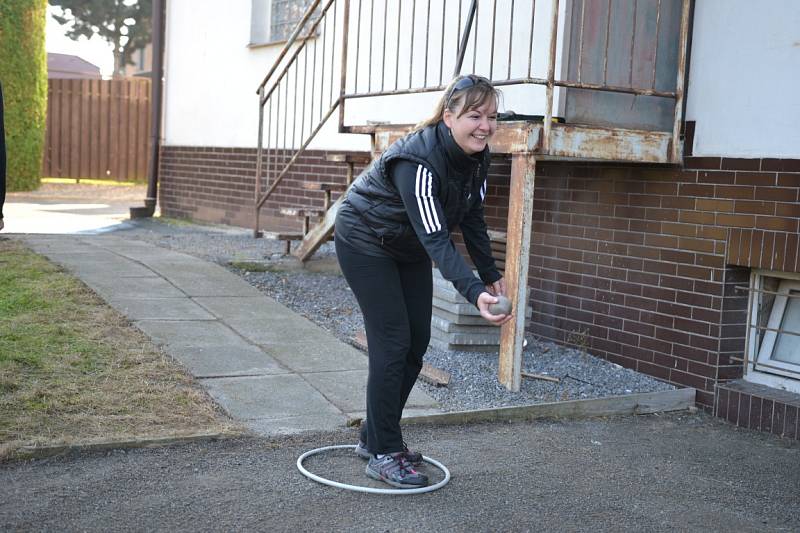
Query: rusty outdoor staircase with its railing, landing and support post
[{"left": 253, "top": 0, "right": 690, "bottom": 390}]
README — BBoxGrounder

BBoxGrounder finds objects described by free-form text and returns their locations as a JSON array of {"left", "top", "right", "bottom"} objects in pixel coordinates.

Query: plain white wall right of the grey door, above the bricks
[{"left": 686, "top": 0, "right": 800, "bottom": 158}]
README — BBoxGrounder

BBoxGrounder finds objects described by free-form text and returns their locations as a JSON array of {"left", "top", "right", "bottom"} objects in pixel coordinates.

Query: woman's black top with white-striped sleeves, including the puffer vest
[{"left": 336, "top": 122, "right": 501, "bottom": 304}]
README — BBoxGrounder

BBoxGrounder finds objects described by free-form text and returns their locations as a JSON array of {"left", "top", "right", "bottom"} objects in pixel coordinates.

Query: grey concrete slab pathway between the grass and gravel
[{"left": 20, "top": 234, "right": 442, "bottom": 435}]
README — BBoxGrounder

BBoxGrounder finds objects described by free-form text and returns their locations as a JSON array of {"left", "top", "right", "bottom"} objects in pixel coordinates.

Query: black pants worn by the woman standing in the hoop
[{"left": 336, "top": 235, "right": 433, "bottom": 454}]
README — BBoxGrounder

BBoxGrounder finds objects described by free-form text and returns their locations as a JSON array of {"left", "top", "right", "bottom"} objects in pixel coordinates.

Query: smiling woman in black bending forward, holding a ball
[{"left": 335, "top": 75, "right": 511, "bottom": 488}]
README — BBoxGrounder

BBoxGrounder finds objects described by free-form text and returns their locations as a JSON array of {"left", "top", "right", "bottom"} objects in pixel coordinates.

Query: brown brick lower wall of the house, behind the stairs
[{"left": 160, "top": 146, "right": 800, "bottom": 408}]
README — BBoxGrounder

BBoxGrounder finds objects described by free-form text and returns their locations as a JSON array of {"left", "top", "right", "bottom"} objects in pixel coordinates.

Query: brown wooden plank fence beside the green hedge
[{"left": 42, "top": 78, "right": 150, "bottom": 180}]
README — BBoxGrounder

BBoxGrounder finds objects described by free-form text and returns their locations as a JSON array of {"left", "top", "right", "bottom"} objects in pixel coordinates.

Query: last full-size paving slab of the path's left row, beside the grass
[{"left": 202, "top": 374, "right": 343, "bottom": 420}]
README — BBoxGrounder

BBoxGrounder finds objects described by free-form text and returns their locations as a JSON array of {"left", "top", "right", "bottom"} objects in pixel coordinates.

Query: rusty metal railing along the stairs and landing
[{"left": 256, "top": 0, "right": 690, "bottom": 231}]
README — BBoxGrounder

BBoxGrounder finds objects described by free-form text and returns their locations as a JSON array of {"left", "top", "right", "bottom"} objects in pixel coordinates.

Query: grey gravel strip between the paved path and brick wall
[{"left": 123, "top": 219, "right": 675, "bottom": 411}]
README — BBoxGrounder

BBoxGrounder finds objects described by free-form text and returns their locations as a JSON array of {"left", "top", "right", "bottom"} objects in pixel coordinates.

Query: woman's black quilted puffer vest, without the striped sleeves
[{"left": 345, "top": 122, "right": 490, "bottom": 260}]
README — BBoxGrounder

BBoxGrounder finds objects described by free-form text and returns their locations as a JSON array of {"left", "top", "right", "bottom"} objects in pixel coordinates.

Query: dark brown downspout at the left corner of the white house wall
[{"left": 130, "top": 0, "right": 167, "bottom": 218}]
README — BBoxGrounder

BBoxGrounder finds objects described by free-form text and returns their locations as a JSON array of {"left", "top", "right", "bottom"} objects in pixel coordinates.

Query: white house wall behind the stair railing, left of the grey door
[{"left": 164, "top": 0, "right": 566, "bottom": 150}]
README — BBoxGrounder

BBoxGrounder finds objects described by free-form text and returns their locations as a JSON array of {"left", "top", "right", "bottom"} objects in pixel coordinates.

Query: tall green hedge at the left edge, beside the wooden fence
[{"left": 0, "top": 0, "right": 47, "bottom": 191}]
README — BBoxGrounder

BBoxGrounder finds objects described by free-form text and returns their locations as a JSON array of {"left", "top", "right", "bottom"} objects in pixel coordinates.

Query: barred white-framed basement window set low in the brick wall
[{"left": 747, "top": 272, "right": 800, "bottom": 389}]
